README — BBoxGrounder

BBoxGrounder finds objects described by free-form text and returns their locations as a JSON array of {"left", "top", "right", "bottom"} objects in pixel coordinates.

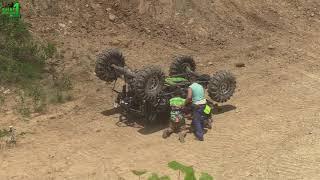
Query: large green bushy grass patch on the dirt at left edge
[{"left": 0, "top": 14, "right": 73, "bottom": 118}]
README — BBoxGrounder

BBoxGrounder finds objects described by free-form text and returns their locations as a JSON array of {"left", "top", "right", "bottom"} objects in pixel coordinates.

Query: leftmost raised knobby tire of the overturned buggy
[{"left": 95, "top": 49, "right": 125, "bottom": 82}]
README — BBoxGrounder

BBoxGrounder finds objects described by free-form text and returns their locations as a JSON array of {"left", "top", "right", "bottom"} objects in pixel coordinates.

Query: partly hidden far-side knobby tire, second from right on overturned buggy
[{"left": 169, "top": 56, "right": 196, "bottom": 76}]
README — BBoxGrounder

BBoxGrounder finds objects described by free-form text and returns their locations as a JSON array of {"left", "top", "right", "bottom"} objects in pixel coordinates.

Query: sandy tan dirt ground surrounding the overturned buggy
[{"left": 0, "top": 0, "right": 320, "bottom": 180}]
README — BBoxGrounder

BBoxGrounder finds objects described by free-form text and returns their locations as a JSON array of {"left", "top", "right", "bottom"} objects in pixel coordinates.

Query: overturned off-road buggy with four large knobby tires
[{"left": 95, "top": 49, "right": 236, "bottom": 123}]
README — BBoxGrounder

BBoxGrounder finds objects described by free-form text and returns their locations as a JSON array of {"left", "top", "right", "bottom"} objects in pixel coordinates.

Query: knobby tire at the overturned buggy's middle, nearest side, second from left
[{"left": 134, "top": 66, "right": 165, "bottom": 102}]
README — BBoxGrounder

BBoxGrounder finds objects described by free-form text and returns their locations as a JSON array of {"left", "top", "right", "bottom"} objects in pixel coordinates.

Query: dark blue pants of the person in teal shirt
[{"left": 191, "top": 105, "right": 205, "bottom": 141}]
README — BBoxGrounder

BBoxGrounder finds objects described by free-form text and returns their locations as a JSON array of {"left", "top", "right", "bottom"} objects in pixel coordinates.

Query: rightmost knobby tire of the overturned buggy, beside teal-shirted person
[{"left": 208, "top": 71, "right": 236, "bottom": 103}]
